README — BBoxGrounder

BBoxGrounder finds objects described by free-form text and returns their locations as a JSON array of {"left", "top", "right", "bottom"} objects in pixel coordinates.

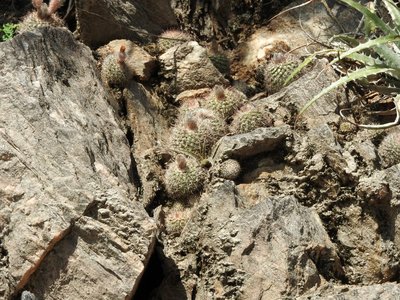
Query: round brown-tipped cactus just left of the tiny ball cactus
[{"left": 165, "top": 154, "right": 207, "bottom": 199}]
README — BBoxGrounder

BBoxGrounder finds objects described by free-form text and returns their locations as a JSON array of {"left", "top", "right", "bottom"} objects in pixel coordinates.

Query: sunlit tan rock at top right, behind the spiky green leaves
[{"left": 237, "top": 1, "right": 358, "bottom": 67}]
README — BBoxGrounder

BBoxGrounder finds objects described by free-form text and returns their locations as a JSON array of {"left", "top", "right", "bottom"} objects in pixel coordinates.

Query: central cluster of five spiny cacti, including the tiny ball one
[{"left": 165, "top": 86, "right": 272, "bottom": 198}]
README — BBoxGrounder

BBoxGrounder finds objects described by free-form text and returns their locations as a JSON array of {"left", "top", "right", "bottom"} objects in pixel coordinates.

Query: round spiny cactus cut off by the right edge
[{"left": 378, "top": 131, "right": 400, "bottom": 168}]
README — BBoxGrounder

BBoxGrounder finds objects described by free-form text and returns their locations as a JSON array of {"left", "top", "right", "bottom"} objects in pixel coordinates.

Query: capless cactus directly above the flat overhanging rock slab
[{"left": 231, "top": 105, "right": 273, "bottom": 133}]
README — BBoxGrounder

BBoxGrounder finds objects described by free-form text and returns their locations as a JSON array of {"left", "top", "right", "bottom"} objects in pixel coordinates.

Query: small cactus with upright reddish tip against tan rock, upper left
[{"left": 101, "top": 45, "right": 131, "bottom": 88}]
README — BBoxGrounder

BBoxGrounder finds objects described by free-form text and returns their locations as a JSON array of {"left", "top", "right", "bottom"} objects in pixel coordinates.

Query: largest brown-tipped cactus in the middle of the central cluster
[{"left": 170, "top": 108, "right": 226, "bottom": 158}]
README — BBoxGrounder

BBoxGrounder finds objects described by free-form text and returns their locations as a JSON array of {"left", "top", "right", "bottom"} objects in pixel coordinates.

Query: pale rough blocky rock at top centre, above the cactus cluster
[{"left": 160, "top": 41, "right": 228, "bottom": 93}]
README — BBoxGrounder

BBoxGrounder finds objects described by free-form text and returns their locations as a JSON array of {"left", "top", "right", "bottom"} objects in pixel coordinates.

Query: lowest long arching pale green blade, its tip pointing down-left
[{"left": 297, "top": 66, "right": 395, "bottom": 118}]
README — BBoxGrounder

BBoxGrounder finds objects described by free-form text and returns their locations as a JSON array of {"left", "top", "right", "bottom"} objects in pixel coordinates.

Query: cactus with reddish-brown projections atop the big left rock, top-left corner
[{"left": 18, "top": 0, "right": 64, "bottom": 33}]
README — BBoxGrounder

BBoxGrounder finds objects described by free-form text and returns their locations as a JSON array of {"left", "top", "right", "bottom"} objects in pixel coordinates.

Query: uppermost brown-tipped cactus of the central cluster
[{"left": 205, "top": 85, "right": 247, "bottom": 120}]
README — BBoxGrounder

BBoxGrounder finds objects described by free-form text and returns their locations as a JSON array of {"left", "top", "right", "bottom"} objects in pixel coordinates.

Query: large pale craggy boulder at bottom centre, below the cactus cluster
[{"left": 153, "top": 181, "right": 343, "bottom": 299}]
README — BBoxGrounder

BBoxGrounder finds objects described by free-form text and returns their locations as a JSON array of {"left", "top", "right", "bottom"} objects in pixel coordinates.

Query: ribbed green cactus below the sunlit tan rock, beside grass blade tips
[{"left": 264, "top": 61, "right": 298, "bottom": 94}]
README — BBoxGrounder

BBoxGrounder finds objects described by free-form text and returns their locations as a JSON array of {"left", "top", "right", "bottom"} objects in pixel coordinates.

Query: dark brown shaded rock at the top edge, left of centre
[{"left": 75, "top": 0, "right": 177, "bottom": 48}]
